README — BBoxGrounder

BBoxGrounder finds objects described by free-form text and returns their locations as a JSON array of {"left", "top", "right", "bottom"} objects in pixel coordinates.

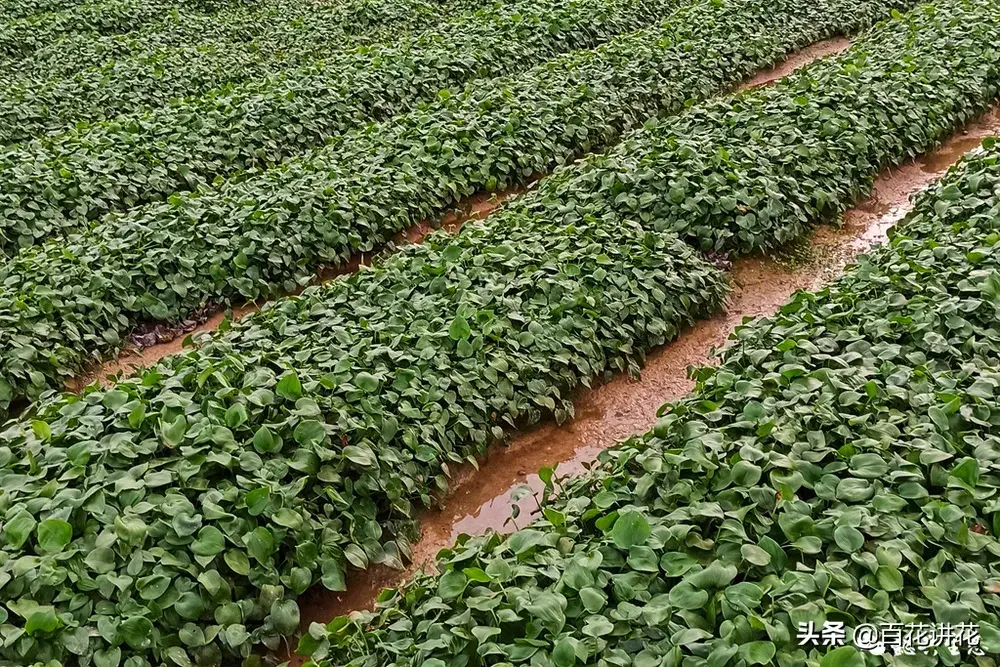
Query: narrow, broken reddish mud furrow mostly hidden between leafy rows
[{"left": 72, "top": 37, "right": 851, "bottom": 391}]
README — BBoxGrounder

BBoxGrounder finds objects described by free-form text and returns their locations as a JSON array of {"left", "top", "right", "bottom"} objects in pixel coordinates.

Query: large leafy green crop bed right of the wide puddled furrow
[{"left": 302, "top": 128, "right": 1000, "bottom": 667}]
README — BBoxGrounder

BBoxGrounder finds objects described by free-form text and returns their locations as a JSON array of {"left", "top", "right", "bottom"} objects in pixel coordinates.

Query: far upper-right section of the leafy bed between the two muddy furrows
[{"left": 520, "top": 1, "right": 1000, "bottom": 252}]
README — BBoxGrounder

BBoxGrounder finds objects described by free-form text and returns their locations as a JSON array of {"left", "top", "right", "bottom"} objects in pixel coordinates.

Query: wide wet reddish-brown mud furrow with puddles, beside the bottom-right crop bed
[{"left": 280, "top": 105, "right": 1000, "bottom": 666}]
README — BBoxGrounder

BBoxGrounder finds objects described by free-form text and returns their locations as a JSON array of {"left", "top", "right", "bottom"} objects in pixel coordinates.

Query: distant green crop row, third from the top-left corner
[{"left": 0, "top": 0, "right": 482, "bottom": 143}]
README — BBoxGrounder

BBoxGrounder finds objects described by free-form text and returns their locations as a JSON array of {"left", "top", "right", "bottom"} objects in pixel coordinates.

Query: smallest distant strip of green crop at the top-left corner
[{"left": 0, "top": 0, "right": 237, "bottom": 56}]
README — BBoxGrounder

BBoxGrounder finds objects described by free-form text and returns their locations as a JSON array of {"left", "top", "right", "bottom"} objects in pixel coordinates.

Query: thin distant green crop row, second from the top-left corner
[{"left": 0, "top": 0, "right": 312, "bottom": 77}]
